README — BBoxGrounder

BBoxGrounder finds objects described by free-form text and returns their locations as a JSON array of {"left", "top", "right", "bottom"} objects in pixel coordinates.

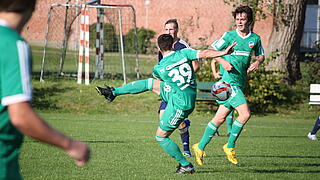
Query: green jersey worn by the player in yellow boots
[{"left": 211, "top": 29, "right": 264, "bottom": 89}]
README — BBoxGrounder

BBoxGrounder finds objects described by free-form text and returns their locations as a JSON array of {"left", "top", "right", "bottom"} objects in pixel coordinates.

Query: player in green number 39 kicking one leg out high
[{"left": 96, "top": 34, "right": 235, "bottom": 173}]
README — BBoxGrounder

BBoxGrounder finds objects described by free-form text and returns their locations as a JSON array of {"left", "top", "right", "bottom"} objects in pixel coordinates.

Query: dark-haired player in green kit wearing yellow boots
[{"left": 192, "top": 6, "right": 265, "bottom": 165}]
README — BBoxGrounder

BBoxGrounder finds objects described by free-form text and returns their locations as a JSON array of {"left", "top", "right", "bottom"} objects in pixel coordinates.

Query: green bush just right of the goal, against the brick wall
[{"left": 124, "top": 28, "right": 156, "bottom": 54}]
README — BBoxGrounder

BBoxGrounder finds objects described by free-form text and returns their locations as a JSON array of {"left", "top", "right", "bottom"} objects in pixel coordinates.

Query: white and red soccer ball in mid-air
[{"left": 211, "top": 81, "right": 232, "bottom": 101}]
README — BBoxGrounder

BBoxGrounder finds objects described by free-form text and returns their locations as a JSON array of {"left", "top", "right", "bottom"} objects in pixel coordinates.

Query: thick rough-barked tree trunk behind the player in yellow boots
[{"left": 266, "top": 0, "right": 307, "bottom": 84}]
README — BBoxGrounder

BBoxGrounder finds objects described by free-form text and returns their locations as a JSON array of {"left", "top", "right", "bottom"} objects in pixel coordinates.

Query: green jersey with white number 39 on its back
[{"left": 153, "top": 49, "right": 199, "bottom": 110}]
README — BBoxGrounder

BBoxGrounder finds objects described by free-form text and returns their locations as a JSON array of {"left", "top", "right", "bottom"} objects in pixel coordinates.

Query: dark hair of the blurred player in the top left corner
[{"left": 0, "top": 0, "right": 37, "bottom": 13}]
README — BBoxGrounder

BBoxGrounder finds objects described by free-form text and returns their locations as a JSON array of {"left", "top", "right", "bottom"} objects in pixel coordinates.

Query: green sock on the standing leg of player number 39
[{"left": 156, "top": 136, "right": 190, "bottom": 166}]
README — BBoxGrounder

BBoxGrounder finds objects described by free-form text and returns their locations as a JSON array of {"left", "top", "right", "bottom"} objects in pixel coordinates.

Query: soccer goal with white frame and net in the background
[{"left": 40, "top": 4, "right": 140, "bottom": 84}]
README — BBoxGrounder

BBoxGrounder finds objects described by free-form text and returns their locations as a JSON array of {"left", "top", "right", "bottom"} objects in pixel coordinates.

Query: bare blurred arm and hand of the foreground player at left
[{"left": 8, "top": 101, "right": 90, "bottom": 166}]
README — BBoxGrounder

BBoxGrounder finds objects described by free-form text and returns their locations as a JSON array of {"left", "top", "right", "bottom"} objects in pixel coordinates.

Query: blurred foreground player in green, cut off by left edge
[{"left": 0, "top": 0, "right": 90, "bottom": 180}]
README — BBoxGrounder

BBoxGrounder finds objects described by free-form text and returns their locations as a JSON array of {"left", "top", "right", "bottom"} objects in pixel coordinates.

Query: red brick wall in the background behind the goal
[{"left": 23, "top": 0, "right": 272, "bottom": 47}]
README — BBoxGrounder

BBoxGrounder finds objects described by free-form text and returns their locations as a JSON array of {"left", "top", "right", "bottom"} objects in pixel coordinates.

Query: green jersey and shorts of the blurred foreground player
[{"left": 0, "top": 20, "right": 32, "bottom": 179}]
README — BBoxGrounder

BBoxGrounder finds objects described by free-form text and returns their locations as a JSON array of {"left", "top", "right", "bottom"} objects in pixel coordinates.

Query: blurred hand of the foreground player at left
[{"left": 66, "top": 140, "right": 90, "bottom": 166}]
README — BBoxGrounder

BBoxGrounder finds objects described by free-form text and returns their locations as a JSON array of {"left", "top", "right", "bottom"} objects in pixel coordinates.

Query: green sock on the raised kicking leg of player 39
[{"left": 112, "top": 78, "right": 154, "bottom": 96}]
